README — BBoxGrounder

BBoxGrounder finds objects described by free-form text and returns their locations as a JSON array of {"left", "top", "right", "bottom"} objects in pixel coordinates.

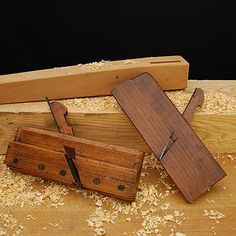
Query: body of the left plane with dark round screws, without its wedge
[{"left": 5, "top": 127, "right": 143, "bottom": 201}]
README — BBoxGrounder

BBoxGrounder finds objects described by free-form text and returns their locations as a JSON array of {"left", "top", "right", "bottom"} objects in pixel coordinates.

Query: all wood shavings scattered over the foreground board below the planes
[{"left": 0, "top": 154, "right": 230, "bottom": 236}]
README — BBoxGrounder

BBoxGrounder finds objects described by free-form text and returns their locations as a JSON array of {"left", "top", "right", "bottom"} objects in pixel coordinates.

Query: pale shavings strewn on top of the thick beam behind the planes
[{"left": 62, "top": 91, "right": 236, "bottom": 113}]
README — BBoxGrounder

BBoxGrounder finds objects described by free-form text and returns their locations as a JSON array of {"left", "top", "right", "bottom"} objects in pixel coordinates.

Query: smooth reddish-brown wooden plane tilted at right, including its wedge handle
[{"left": 112, "top": 73, "right": 226, "bottom": 202}]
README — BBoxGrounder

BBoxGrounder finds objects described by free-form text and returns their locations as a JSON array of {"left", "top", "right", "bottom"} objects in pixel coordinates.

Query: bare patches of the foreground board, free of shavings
[{"left": 0, "top": 156, "right": 236, "bottom": 236}]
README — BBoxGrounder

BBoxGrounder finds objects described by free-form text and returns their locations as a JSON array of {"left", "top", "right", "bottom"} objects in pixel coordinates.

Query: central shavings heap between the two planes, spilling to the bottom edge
[{"left": 78, "top": 154, "right": 185, "bottom": 236}]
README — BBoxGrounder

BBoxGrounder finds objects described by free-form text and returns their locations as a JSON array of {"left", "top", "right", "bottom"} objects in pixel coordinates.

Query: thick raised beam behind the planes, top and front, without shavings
[{"left": 0, "top": 81, "right": 236, "bottom": 153}]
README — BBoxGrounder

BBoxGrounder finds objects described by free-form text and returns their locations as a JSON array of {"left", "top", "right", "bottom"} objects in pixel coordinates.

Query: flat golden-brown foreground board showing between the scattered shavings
[{"left": 0, "top": 154, "right": 236, "bottom": 236}]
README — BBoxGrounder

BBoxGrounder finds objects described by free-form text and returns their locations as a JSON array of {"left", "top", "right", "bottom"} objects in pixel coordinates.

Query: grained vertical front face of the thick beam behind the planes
[{"left": 0, "top": 112, "right": 236, "bottom": 154}]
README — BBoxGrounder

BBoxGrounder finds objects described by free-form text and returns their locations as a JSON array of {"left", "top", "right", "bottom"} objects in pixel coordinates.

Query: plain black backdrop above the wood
[{"left": 0, "top": 0, "right": 236, "bottom": 79}]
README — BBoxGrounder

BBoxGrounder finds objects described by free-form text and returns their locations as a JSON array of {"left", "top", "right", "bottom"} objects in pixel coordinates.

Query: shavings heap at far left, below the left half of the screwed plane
[{"left": 0, "top": 155, "right": 69, "bottom": 207}]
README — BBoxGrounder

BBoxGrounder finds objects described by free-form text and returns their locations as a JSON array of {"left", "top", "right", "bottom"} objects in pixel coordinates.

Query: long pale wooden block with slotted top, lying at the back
[{"left": 0, "top": 56, "right": 189, "bottom": 104}]
